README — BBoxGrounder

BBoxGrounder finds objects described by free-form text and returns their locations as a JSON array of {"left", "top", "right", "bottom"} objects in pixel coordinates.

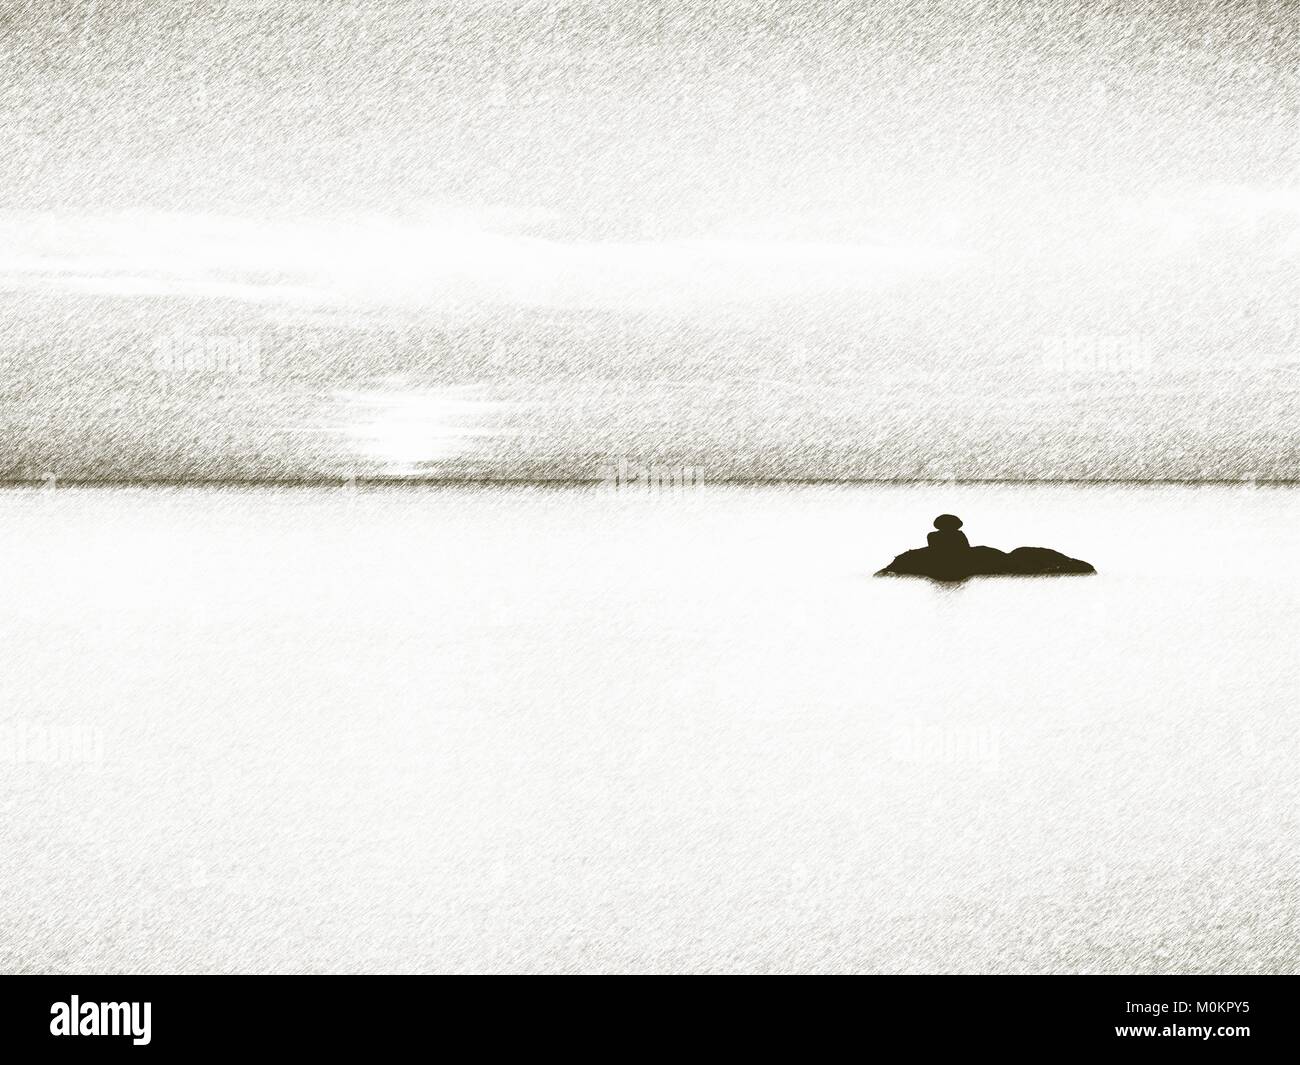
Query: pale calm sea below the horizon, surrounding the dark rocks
[{"left": 0, "top": 486, "right": 1300, "bottom": 973}]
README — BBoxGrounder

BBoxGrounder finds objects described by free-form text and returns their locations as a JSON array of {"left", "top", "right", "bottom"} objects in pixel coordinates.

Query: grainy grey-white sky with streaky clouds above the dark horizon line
[{"left": 0, "top": 0, "right": 1300, "bottom": 480}]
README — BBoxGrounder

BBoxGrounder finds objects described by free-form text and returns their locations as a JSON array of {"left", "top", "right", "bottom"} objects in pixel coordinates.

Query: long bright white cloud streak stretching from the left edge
[{"left": 0, "top": 209, "right": 962, "bottom": 312}]
